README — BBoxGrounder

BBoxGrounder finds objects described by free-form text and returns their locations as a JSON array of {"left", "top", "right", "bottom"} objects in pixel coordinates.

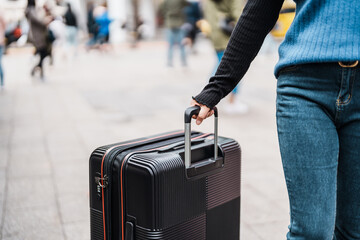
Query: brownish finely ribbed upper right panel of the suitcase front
[{"left": 207, "top": 141, "right": 241, "bottom": 209}]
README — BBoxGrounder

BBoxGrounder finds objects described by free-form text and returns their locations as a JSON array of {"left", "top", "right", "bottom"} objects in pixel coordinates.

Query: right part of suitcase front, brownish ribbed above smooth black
[{"left": 206, "top": 140, "right": 241, "bottom": 240}]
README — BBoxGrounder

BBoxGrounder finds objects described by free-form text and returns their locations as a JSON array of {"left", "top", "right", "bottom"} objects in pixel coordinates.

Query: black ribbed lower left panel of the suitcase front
[{"left": 135, "top": 214, "right": 206, "bottom": 240}]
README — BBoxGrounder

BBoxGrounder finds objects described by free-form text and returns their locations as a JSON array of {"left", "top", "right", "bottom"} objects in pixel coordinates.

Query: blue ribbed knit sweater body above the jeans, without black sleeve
[{"left": 275, "top": 0, "right": 360, "bottom": 76}]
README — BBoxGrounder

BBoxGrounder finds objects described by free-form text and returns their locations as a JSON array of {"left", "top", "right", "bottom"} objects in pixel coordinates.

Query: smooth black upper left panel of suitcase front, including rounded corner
[{"left": 126, "top": 153, "right": 206, "bottom": 230}]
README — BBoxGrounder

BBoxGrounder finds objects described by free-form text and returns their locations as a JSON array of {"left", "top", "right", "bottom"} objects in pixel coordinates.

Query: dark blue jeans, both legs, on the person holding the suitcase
[{"left": 277, "top": 63, "right": 360, "bottom": 240}]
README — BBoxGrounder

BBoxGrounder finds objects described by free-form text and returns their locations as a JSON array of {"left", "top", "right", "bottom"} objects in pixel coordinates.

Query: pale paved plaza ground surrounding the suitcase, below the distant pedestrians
[{"left": 0, "top": 41, "right": 289, "bottom": 240}]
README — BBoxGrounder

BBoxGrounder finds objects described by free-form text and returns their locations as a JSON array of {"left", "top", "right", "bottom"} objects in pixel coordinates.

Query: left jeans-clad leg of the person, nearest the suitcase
[{"left": 277, "top": 65, "right": 339, "bottom": 240}]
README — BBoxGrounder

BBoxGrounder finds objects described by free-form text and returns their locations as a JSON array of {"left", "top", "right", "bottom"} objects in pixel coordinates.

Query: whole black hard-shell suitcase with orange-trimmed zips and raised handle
[{"left": 89, "top": 107, "right": 240, "bottom": 240}]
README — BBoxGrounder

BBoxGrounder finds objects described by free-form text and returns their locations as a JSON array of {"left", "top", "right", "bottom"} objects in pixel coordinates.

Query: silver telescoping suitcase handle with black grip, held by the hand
[{"left": 185, "top": 106, "right": 218, "bottom": 169}]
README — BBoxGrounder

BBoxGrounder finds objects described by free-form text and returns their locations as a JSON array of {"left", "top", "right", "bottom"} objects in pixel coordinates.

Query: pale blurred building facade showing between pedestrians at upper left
[{"left": 0, "top": 0, "right": 161, "bottom": 43}]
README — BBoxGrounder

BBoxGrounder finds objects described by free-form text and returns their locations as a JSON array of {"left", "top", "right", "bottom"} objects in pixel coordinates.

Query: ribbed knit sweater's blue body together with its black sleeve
[{"left": 194, "top": 0, "right": 360, "bottom": 108}]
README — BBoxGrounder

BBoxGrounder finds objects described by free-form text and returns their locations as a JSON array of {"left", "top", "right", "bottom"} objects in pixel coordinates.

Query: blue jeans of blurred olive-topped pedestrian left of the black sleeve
[{"left": 167, "top": 28, "right": 186, "bottom": 66}]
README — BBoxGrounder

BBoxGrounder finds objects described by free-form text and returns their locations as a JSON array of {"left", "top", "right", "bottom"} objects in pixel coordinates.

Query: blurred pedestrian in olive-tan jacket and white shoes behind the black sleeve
[{"left": 204, "top": 0, "right": 248, "bottom": 114}]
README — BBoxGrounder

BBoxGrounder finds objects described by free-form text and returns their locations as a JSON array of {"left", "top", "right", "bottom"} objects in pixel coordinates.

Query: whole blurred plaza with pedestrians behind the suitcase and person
[{"left": 0, "top": 0, "right": 295, "bottom": 240}]
